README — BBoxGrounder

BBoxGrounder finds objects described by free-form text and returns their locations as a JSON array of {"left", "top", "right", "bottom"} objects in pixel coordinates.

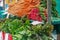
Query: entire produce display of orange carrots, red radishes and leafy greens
[{"left": 0, "top": 0, "right": 57, "bottom": 40}]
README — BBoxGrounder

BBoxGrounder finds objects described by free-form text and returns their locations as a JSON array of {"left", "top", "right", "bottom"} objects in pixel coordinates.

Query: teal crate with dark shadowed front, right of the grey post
[{"left": 52, "top": 17, "right": 60, "bottom": 34}]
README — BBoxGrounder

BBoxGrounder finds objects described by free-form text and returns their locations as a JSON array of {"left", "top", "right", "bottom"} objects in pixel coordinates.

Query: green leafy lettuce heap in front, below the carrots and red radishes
[{"left": 0, "top": 19, "right": 53, "bottom": 40}]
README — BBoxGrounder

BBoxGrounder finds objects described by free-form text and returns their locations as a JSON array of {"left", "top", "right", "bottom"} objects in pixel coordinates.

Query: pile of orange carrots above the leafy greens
[{"left": 8, "top": 0, "right": 40, "bottom": 17}]
